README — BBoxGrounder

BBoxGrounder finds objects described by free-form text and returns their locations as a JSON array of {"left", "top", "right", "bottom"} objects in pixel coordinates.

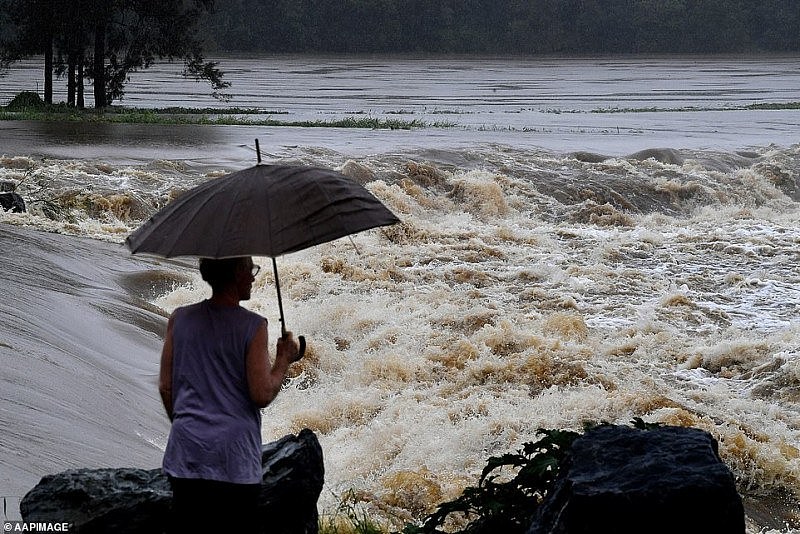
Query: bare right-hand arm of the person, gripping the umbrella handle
[{"left": 247, "top": 321, "right": 299, "bottom": 408}]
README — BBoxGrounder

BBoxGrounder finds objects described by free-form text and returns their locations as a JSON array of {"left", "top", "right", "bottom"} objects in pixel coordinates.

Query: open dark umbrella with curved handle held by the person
[{"left": 125, "top": 164, "right": 399, "bottom": 353}]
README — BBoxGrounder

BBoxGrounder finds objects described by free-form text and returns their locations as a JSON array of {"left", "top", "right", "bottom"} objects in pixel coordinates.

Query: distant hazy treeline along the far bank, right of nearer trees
[{"left": 200, "top": 0, "right": 800, "bottom": 55}]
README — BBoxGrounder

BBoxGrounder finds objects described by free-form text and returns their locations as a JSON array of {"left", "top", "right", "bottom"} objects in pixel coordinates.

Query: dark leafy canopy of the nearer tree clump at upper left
[{"left": 0, "top": 0, "right": 228, "bottom": 108}]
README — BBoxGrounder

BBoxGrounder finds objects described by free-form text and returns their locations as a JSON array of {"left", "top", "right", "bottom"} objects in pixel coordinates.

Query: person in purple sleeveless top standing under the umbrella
[{"left": 159, "top": 257, "right": 302, "bottom": 533}]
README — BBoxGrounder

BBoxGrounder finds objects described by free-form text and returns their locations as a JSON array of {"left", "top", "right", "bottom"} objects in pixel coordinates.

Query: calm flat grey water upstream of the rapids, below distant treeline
[{"left": 0, "top": 57, "right": 800, "bottom": 160}]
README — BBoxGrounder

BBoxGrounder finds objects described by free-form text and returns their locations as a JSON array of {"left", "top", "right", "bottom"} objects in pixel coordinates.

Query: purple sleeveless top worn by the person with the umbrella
[{"left": 162, "top": 300, "right": 265, "bottom": 484}]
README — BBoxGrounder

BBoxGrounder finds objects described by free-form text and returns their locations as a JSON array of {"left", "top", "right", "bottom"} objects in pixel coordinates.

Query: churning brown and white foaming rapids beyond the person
[{"left": 0, "top": 147, "right": 800, "bottom": 532}]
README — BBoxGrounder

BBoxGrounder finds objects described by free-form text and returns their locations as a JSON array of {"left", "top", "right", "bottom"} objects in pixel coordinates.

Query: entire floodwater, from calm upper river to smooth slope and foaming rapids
[{"left": 0, "top": 54, "right": 800, "bottom": 533}]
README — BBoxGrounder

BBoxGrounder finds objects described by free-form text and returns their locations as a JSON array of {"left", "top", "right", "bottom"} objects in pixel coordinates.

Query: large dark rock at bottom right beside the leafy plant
[{"left": 528, "top": 425, "right": 745, "bottom": 534}]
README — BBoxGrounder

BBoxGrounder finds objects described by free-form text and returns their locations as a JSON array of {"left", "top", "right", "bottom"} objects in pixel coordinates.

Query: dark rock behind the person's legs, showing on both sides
[{"left": 20, "top": 429, "right": 324, "bottom": 534}]
